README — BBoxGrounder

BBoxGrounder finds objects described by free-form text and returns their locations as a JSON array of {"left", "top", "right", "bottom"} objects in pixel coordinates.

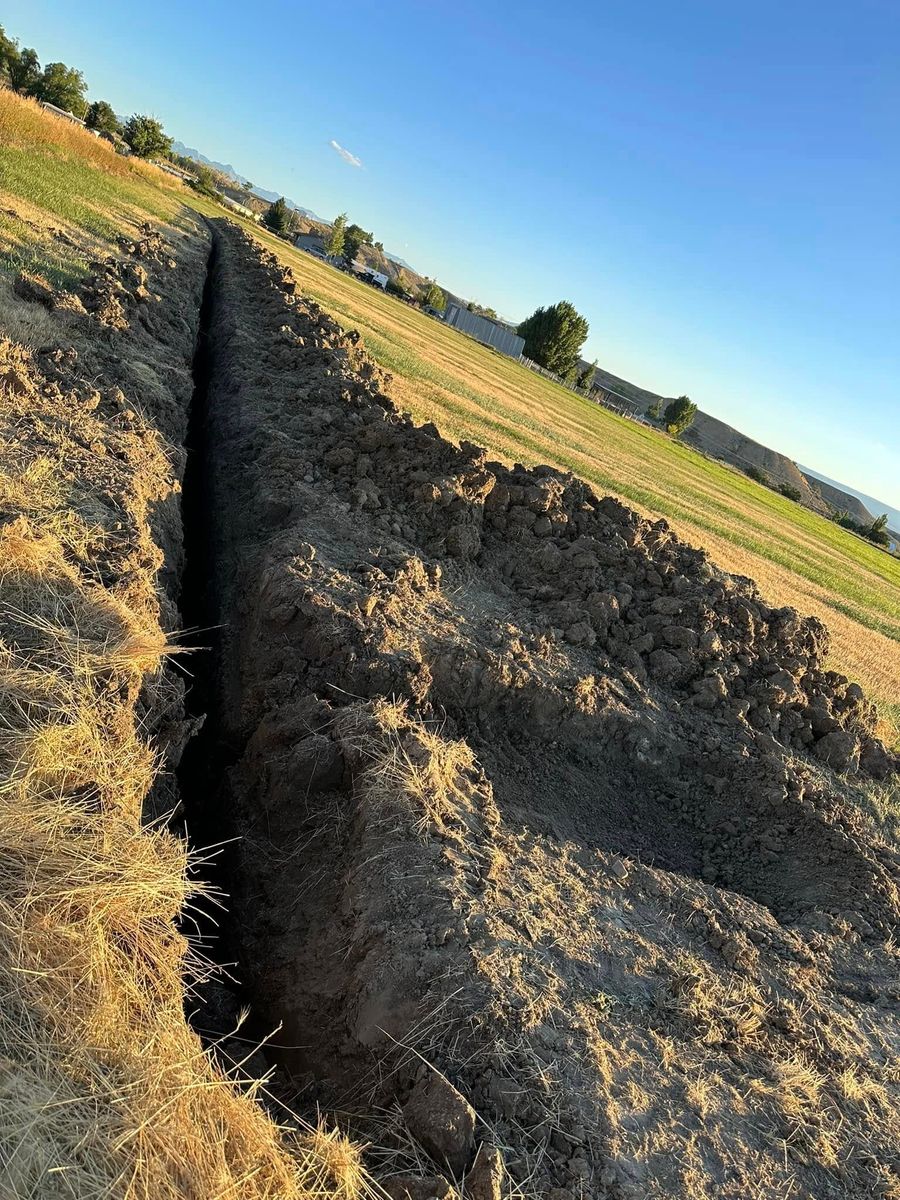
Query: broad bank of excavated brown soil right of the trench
[{"left": 203, "top": 222, "right": 900, "bottom": 1200}]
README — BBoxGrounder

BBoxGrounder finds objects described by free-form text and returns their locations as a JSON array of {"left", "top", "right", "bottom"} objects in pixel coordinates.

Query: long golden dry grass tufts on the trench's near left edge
[{"left": 0, "top": 522, "right": 374, "bottom": 1200}]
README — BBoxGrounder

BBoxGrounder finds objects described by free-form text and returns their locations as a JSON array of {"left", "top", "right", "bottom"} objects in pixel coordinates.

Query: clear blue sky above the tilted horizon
[{"left": 2, "top": 0, "right": 900, "bottom": 508}]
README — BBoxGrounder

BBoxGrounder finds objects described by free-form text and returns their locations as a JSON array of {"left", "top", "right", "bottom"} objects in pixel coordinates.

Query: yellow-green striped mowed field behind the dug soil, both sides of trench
[{"left": 0, "top": 95, "right": 900, "bottom": 739}]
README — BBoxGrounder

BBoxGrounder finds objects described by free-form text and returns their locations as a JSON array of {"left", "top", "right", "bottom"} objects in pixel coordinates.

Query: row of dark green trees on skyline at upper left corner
[{"left": 0, "top": 25, "right": 172, "bottom": 158}]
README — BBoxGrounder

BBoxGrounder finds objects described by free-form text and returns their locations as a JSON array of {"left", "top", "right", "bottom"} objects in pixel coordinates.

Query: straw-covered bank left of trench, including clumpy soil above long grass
[{"left": 0, "top": 305, "right": 371, "bottom": 1200}]
